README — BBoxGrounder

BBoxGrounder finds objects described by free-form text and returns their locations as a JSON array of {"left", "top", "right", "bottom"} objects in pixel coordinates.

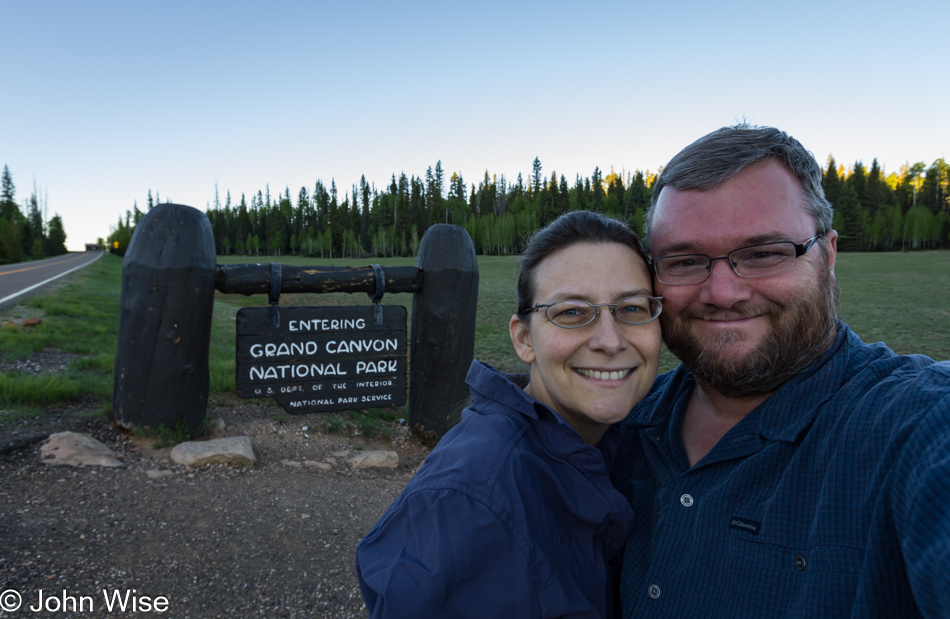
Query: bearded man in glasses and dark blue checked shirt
[{"left": 612, "top": 125, "right": 950, "bottom": 619}]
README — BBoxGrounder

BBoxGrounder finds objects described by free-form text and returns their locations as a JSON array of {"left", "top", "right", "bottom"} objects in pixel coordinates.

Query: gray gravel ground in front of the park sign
[{"left": 0, "top": 358, "right": 427, "bottom": 618}]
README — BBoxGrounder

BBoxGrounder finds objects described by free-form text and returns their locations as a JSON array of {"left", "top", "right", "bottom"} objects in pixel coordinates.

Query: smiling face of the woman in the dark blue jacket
[{"left": 509, "top": 243, "right": 660, "bottom": 445}]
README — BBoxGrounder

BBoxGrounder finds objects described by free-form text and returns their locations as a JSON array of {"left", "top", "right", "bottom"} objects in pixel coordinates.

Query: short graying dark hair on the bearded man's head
[{"left": 644, "top": 123, "right": 834, "bottom": 247}]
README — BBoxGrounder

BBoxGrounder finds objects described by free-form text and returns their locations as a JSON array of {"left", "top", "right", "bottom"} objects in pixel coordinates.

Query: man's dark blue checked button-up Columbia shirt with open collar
[{"left": 612, "top": 323, "right": 950, "bottom": 619}]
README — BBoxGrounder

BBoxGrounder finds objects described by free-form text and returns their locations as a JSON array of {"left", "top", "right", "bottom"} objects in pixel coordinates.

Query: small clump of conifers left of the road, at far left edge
[{"left": 0, "top": 165, "right": 66, "bottom": 264}]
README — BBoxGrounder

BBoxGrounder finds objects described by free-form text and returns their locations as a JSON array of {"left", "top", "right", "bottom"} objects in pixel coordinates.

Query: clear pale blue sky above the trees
[{"left": 0, "top": 0, "right": 950, "bottom": 249}]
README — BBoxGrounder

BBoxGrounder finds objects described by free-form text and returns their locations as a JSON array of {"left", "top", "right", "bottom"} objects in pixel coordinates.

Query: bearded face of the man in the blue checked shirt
[{"left": 650, "top": 160, "right": 837, "bottom": 397}]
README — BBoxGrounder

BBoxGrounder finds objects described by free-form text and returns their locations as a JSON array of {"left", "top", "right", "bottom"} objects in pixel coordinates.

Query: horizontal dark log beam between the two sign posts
[{"left": 214, "top": 263, "right": 421, "bottom": 295}]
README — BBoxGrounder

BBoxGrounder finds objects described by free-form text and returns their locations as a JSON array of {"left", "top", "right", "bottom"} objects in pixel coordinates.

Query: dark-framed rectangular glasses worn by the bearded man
[{"left": 650, "top": 234, "right": 821, "bottom": 286}]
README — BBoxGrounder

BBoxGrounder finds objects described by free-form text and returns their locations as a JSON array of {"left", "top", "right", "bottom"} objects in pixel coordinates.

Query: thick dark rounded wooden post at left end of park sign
[{"left": 112, "top": 204, "right": 215, "bottom": 432}]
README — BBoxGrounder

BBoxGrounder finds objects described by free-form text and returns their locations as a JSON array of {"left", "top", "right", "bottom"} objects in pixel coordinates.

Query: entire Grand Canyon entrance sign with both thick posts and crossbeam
[{"left": 112, "top": 204, "right": 478, "bottom": 436}]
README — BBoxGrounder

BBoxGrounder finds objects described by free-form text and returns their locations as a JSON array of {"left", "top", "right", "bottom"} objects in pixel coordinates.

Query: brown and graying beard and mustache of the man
[{"left": 660, "top": 270, "right": 839, "bottom": 398}]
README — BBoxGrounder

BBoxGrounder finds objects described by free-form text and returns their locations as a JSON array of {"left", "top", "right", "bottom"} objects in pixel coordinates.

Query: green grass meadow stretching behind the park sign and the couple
[{"left": 0, "top": 251, "right": 950, "bottom": 421}]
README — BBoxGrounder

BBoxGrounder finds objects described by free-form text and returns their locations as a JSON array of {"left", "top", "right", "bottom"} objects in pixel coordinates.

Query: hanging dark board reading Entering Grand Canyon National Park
[{"left": 235, "top": 305, "right": 408, "bottom": 414}]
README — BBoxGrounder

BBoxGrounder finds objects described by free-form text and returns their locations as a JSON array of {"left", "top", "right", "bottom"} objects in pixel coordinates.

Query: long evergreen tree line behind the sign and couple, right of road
[{"left": 100, "top": 156, "right": 950, "bottom": 259}]
